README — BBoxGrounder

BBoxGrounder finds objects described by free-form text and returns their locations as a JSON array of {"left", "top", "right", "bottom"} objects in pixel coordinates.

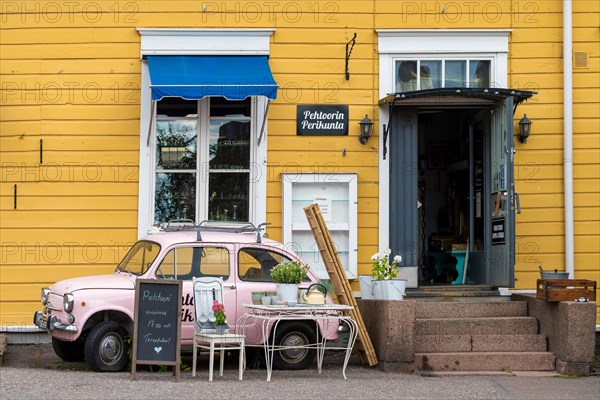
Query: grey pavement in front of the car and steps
[{"left": 0, "top": 344, "right": 600, "bottom": 400}]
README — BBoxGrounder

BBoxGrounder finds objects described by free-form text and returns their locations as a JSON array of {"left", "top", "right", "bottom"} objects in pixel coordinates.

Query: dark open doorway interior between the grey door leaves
[{"left": 417, "top": 109, "right": 488, "bottom": 285}]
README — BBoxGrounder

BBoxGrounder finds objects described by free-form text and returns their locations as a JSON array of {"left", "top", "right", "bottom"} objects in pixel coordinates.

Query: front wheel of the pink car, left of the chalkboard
[{"left": 85, "top": 321, "right": 129, "bottom": 372}]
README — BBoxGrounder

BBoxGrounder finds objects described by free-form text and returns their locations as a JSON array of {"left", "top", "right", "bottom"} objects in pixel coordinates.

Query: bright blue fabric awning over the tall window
[{"left": 147, "top": 55, "right": 278, "bottom": 101}]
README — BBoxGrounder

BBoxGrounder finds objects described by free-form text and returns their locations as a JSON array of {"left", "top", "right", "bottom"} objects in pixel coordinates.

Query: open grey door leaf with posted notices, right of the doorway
[{"left": 463, "top": 97, "right": 515, "bottom": 287}]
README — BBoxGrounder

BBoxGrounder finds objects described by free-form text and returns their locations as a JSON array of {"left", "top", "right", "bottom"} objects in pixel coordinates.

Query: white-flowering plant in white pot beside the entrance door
[{"left": 371, "top": 249, "right": 406, "bottom": 300}]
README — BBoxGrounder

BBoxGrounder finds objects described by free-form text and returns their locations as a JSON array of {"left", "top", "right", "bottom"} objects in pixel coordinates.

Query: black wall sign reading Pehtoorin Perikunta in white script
[{"left": 296, "top": 104, "right": 348, "bottom": 136}]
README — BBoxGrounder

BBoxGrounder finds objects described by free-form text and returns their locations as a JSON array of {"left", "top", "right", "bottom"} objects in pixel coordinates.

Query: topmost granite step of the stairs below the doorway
[{"left": 415, "top": 301, "right": 527, "bottom": 319}]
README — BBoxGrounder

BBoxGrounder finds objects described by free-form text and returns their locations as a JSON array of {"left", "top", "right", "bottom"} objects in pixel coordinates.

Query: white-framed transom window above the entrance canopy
[{"left": 377, "top": 29, "right": 510, "bottom": 98}]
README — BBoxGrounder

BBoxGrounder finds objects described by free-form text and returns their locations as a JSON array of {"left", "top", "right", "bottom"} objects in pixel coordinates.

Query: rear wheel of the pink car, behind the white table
[{"left": 273, "top": 321, "right": 317, "bottom": 369}]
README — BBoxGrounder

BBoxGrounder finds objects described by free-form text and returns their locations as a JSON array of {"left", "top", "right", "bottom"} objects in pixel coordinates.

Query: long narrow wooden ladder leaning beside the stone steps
[{"left": 304, "top": 204, "right": 378, "bottom": 367}]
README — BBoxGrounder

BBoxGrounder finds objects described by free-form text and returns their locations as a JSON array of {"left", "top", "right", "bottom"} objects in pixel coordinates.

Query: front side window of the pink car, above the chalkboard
[{"left": 156, "top": 247, "right": 229, "bottom": 280}]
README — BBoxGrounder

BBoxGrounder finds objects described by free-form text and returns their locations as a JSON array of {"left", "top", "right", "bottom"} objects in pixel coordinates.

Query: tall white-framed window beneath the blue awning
[{"left": 137, "top": 28, "right": 274, "bottom": 237}]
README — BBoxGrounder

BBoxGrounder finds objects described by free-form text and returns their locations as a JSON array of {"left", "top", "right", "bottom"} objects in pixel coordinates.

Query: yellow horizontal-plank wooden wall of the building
[{"left": 0, "top": 0, "right": 600, "bottom": 326}]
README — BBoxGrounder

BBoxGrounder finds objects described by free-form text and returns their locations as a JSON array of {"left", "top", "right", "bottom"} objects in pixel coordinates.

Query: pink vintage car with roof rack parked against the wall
[{"left": 34, "top": 223, "right": 337, "bottom": 371}]
